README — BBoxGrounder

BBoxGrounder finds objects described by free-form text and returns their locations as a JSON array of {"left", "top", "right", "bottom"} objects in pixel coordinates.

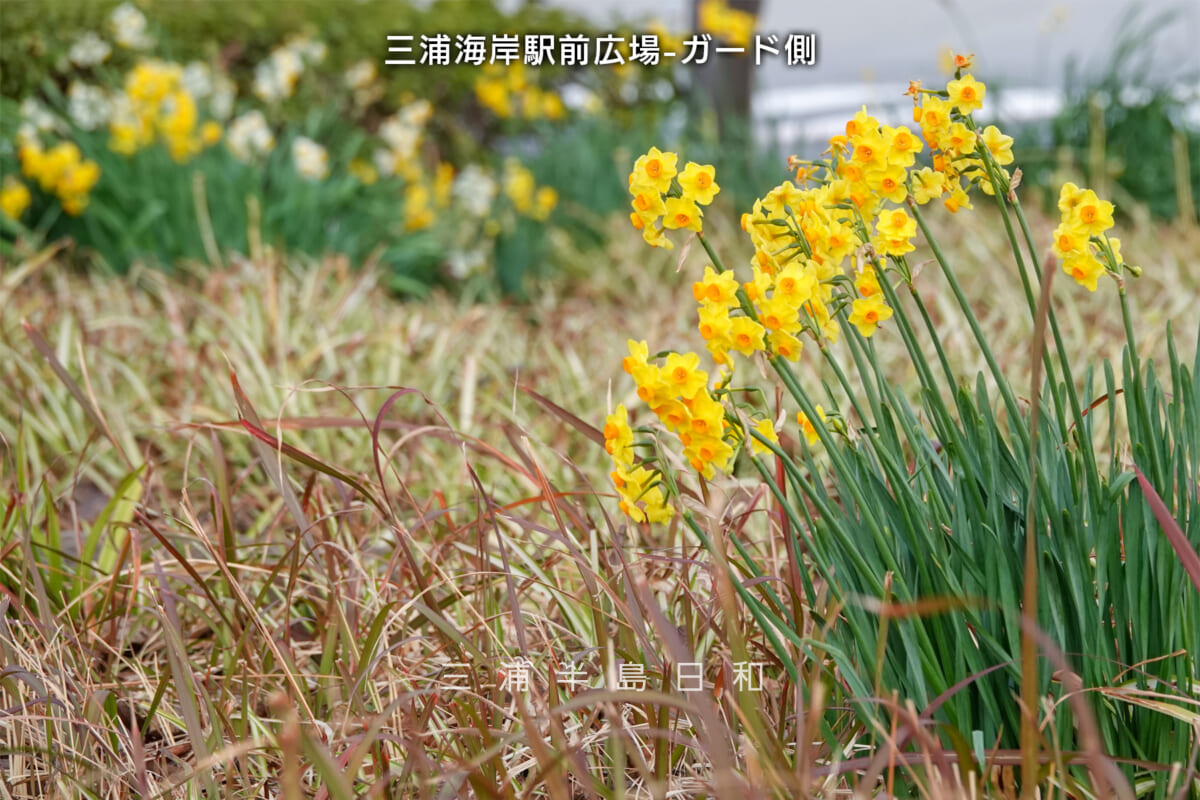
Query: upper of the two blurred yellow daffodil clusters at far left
[{"left": 108, "top": 59, "right": 222, "bottom": 163}]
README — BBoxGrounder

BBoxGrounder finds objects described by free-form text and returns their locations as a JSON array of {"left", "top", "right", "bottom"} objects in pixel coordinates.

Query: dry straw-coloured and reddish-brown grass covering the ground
[{"left": 0, "top": 196, "right": 1200, "bottom": 798}]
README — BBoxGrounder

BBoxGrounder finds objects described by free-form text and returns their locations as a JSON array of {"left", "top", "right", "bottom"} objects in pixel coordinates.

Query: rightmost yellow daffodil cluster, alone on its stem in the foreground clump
[{"left": 1054, "top": 184, "right": 1141, "bottom": 291}]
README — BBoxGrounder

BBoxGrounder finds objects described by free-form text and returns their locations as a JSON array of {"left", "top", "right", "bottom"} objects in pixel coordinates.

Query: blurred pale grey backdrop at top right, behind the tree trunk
[{"left": 528, "top": 0, "right": 1200, "bottom": 88}]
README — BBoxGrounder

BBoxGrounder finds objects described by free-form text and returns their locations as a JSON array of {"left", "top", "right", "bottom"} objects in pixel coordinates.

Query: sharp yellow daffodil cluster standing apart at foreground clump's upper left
[{"left": 629, "top": 148, "right": 721, "bottom": 249}]
